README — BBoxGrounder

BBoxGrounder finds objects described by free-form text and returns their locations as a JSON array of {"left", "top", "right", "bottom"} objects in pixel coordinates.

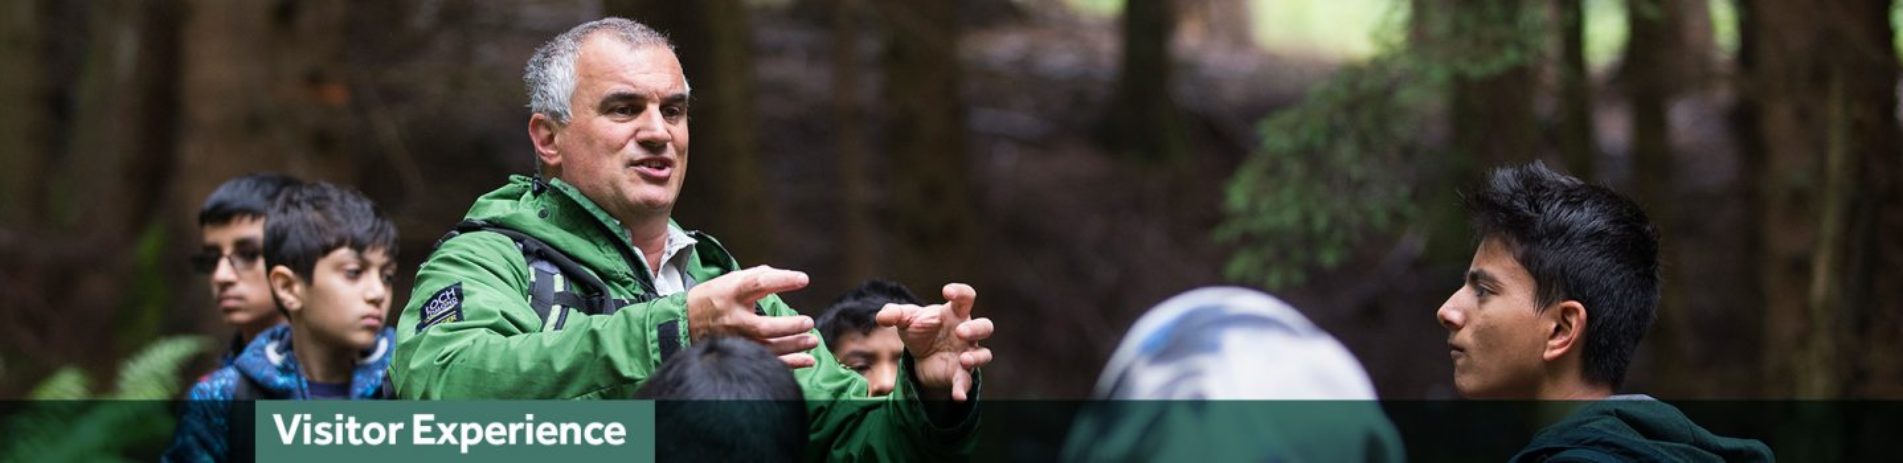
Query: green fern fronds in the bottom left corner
[{"left": 0, "top": 335, "right": 211, "bottom": 461}]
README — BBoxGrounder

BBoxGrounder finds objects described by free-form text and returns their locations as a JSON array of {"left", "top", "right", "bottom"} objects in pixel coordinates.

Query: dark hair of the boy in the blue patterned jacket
[{"left": 265, "top": 181, "right": 396, "bottom": 278}]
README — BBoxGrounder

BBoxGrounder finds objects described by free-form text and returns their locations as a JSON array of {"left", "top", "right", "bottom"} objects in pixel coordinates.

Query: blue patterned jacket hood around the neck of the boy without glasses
[{"left": 232, "top": 324, "right": 396, "bottom": 400}]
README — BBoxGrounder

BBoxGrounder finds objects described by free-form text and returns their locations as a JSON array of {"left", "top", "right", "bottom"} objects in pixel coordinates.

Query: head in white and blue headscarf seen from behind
[{"left": 1064, "top": 288, "right": 1403, "bottom": 461}]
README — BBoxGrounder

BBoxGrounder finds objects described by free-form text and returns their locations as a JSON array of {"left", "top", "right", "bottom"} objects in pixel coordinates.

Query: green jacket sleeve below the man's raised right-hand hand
[{"left": 763, "top": 295, "right": 982, "bottom": 461}]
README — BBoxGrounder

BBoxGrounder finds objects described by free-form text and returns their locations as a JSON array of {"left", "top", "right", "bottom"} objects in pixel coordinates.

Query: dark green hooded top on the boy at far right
[{"left": 1513, "top": 396, "right": 1775, "bottom": 461}]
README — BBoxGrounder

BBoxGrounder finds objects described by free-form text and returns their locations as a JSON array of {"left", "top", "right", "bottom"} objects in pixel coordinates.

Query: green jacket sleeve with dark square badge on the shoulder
[{"left": 390, "top": 232, "right": 685, "bottom": 398}]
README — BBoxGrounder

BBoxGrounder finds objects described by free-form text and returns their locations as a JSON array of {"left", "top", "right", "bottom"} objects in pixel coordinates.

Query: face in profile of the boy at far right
[{"left": 1437, "top": 238, "right": 1551, "bottom": 398}]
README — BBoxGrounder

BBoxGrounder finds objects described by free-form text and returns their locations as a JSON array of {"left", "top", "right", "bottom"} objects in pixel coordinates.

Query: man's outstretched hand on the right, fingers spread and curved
[{"left": 879, "top": 284, "right": 991, "bottom": 402}]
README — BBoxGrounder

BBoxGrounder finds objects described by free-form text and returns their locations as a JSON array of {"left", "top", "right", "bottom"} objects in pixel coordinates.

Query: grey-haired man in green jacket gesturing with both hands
[{"left": 390, "top": 17, "right": 993, "bottom": 459}]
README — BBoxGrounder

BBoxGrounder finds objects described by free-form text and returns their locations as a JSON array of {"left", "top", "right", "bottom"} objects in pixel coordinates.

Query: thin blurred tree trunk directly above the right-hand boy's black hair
[{"left": 1559, "top": 0, "right": 1599, "bottom": 179}]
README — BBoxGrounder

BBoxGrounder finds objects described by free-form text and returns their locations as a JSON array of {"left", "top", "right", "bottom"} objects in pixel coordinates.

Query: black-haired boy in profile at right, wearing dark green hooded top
[{"left": 1437, "top": 162, "right": 1772, "bottom": 461}]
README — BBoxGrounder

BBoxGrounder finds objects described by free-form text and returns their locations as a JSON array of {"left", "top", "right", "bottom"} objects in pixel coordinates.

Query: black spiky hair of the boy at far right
[{"left": 1465, "top": 162, "right": 1659, "bottom": 387}]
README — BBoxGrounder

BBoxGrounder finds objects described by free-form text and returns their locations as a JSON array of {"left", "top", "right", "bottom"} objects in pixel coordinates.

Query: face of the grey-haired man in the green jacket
[{"left": 552, "top": 34, "right": 687, "bottom": 221}]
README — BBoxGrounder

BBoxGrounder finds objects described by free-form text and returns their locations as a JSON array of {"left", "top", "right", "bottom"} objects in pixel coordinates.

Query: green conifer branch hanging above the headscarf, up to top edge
[{"left": 1214, "top": 0, "right": 1549, "bottom": 290}]
